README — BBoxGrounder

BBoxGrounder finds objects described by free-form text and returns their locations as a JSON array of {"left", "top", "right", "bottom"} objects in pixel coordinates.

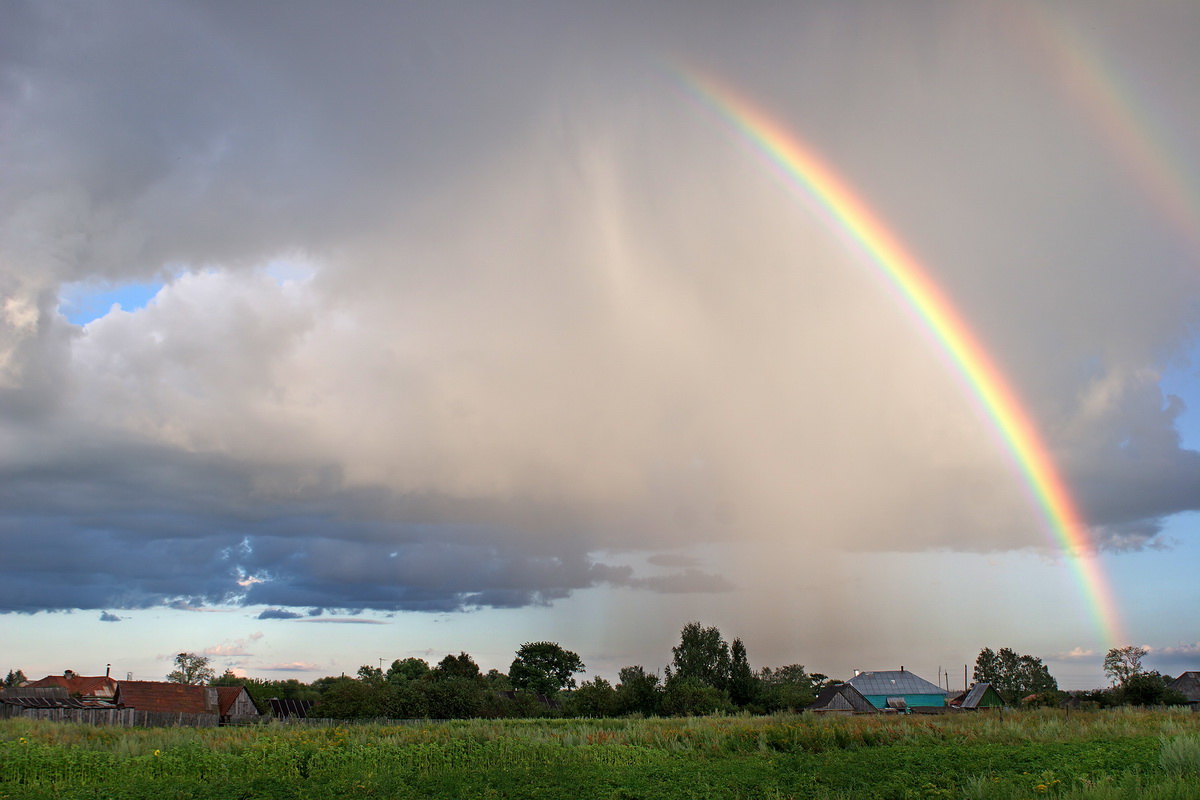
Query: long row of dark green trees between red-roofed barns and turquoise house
[{"left": 213, "top": 622, "right": 841, "bottom": 720}]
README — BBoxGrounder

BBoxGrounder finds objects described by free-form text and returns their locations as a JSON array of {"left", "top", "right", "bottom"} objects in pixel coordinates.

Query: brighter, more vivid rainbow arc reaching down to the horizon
[{"left": 680, "top": 71, "right": 1121, "bottom": 646}]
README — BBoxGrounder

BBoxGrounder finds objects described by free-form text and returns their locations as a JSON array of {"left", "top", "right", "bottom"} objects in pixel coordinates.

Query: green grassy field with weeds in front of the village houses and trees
[{"left": 0, "top": 710, "right": 1200, "bottom": 800}]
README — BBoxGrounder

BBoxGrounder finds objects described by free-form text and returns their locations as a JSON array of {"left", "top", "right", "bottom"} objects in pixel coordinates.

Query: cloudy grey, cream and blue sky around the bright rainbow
[{"left": 0, "top": 0, "right": 1200, "bottom": 686}]
